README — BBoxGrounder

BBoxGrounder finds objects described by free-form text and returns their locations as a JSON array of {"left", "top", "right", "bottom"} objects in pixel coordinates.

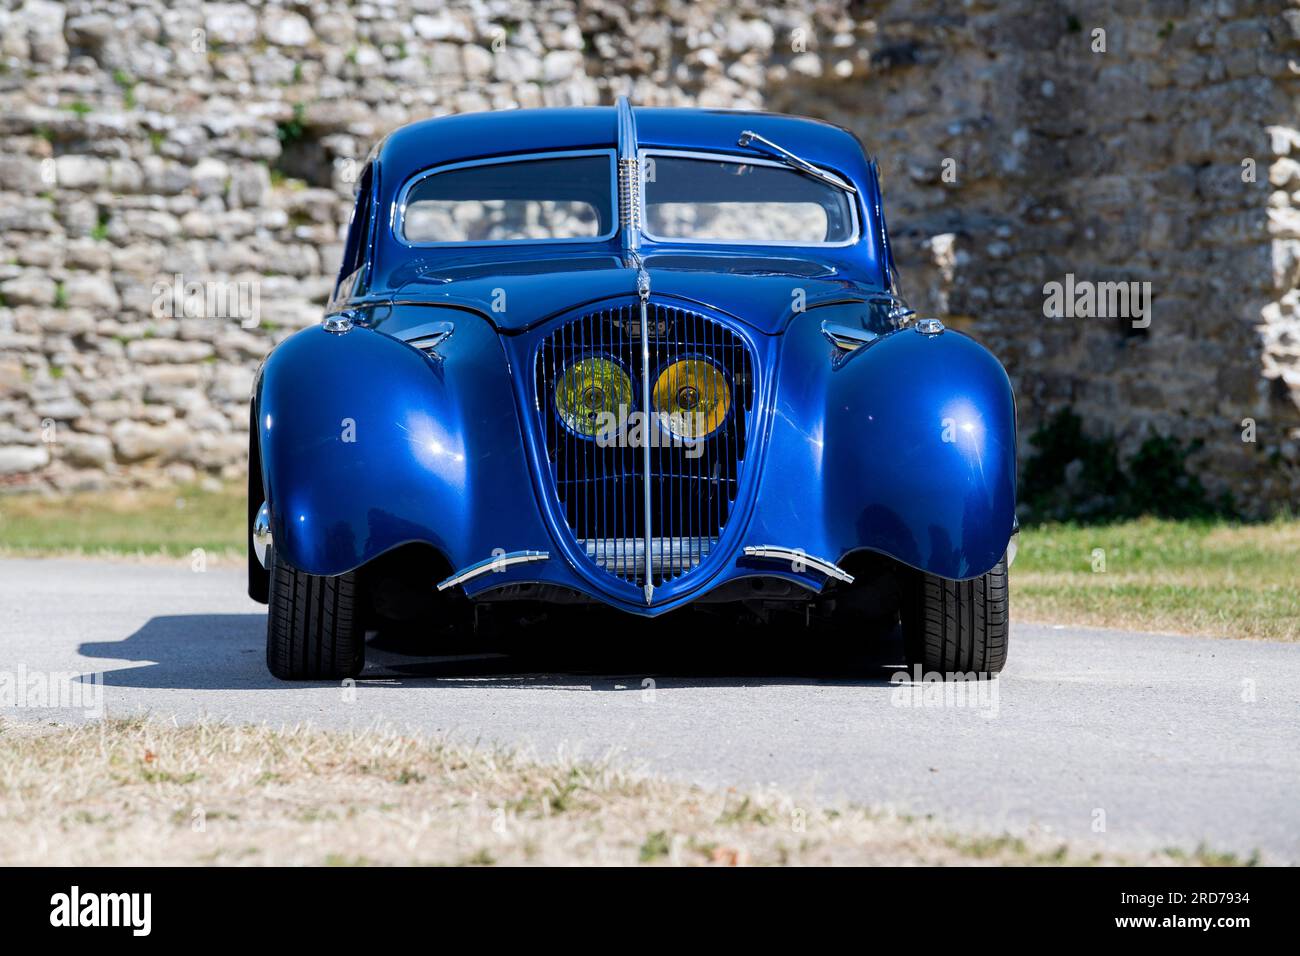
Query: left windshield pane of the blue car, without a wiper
[{"left": 399, "top": 152, "right": 616, "bottom": 245}]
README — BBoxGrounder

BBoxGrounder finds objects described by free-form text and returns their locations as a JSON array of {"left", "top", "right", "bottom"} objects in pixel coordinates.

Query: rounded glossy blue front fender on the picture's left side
[{"left": 255, "top": 312, "right": 550, "bottom": 575}]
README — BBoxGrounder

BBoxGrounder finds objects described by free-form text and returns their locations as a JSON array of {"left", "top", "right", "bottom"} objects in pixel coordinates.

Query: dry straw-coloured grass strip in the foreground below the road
[{"left": 0, "top": 719, "right": 1235, "bottom": 866}]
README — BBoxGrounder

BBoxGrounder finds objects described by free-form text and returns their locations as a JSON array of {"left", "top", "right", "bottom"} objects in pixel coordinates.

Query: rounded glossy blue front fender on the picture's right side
[{"left": 749, "top": 310, "right": 1015, "bottom": 580}]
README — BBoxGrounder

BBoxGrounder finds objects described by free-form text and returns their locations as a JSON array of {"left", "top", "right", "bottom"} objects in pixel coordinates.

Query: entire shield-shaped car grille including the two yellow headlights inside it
[{"left": 534, "top": 302, "right": 754, "bottom": 588}]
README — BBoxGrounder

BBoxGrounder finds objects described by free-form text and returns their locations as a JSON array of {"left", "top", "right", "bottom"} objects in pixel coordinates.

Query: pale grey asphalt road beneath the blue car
[{"left": 0, "top": 559, "right": 1300, "bottom": 862}]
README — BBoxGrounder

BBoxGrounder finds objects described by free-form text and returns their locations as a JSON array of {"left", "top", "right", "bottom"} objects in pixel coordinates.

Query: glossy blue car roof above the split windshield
[{"left": 376, "top": 107, "right": 866, "bottom": 191}]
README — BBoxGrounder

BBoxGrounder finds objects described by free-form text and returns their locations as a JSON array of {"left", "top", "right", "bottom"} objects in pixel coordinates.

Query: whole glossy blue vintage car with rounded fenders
[{"left": 248, "top": 100, "right": 1018, "bottom": 679}]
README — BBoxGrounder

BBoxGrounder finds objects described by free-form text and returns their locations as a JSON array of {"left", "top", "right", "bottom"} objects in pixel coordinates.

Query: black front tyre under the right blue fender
[{"left": 902, "top": 555, "right": 1008, "bottom": 676}]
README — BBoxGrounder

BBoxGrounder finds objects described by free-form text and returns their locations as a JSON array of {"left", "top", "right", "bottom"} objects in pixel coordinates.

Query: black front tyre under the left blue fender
[{"left": 267, "top": 548, "right": 365, "bottom": 680}]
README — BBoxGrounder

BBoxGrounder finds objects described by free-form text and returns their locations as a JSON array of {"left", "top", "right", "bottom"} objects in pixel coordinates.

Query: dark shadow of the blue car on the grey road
[{"left": 78, "top": 614, "right": 902, "bottom": 691}]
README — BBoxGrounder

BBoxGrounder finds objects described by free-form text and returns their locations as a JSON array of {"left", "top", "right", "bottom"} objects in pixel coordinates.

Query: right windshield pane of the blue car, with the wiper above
[{"left": 644, "top": 155, "right": 857, "bottom": 245}]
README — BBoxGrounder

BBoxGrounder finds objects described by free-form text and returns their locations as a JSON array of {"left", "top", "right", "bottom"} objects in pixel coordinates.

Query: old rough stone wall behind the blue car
[{"left": 0, "top": 0, "right": 1300, "bottom": 512}]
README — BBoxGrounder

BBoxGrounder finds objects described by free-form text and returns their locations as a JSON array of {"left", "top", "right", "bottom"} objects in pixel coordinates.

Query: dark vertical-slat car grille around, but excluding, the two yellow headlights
[{"left": 534, "top": 302, "right": 754, "bottom": 588}]
